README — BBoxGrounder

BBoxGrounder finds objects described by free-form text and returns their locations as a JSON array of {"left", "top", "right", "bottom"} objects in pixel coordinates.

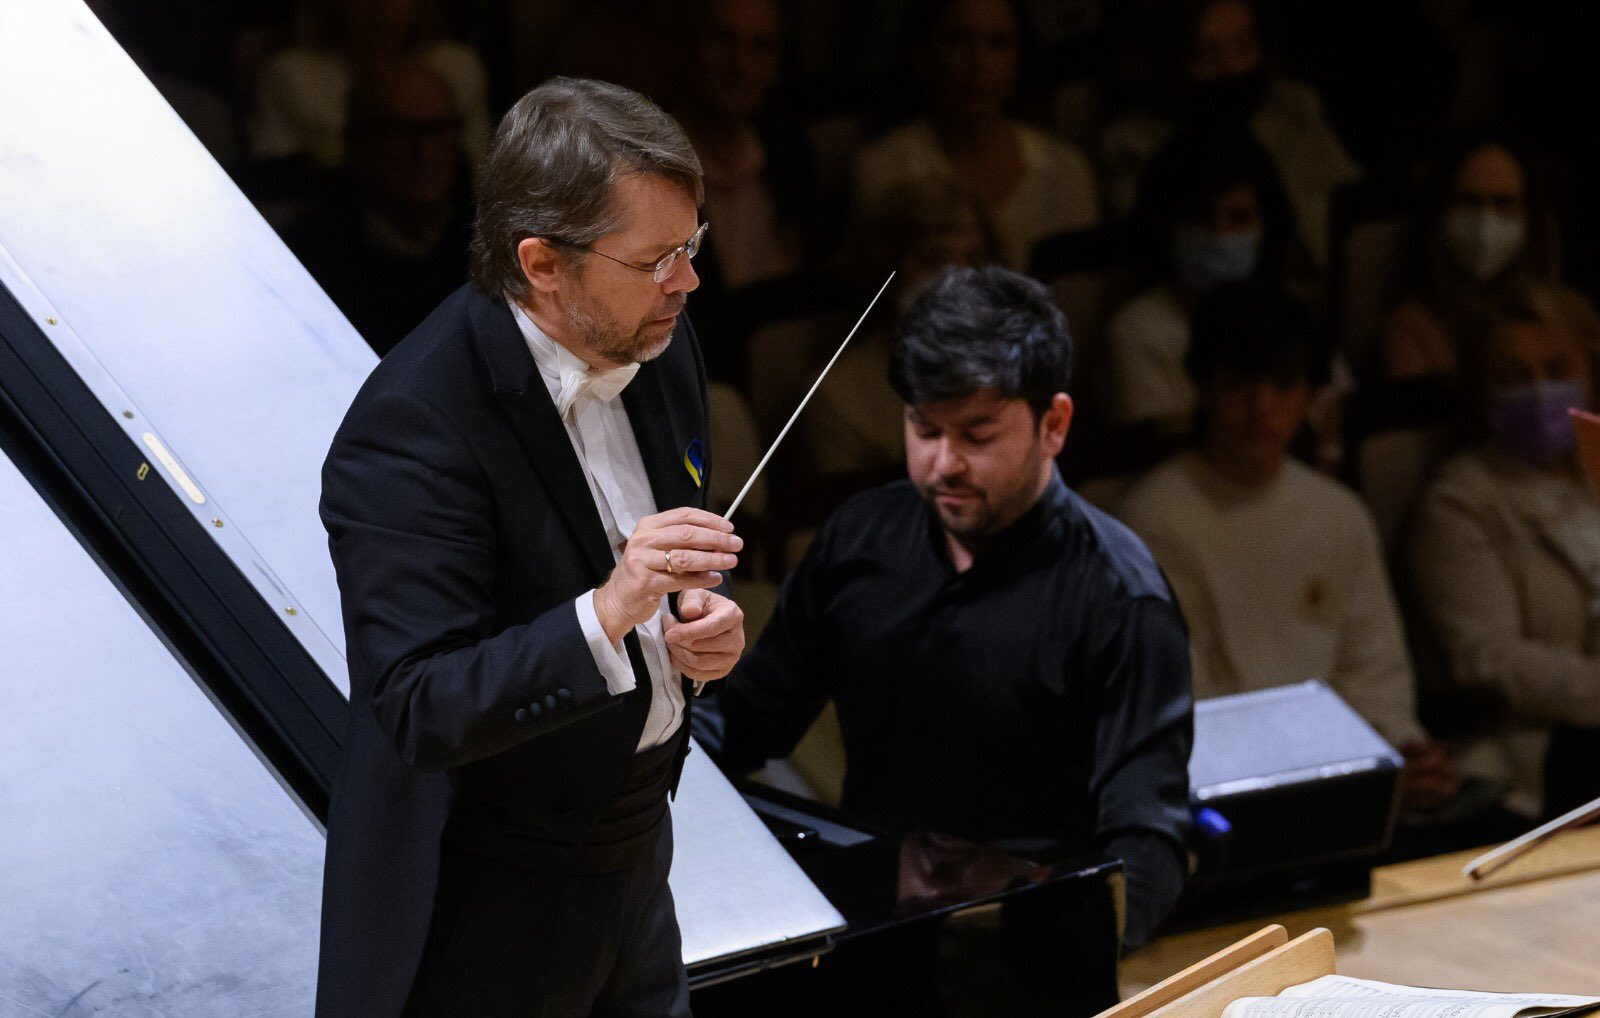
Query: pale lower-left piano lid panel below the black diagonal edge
[{"left": 0, "top": 453, "right": 323, "bottom": 1018}]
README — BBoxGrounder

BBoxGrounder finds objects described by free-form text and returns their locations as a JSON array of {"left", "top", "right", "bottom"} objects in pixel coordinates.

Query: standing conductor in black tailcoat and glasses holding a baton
[{"left": 317, "top": 78, "right": 744, "bottom": 1018}]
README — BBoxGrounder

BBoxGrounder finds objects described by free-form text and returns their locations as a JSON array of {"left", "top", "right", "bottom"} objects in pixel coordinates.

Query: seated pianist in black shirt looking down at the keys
[{"left": 702, "top": 267, "right": 1190, "bottom": 944}]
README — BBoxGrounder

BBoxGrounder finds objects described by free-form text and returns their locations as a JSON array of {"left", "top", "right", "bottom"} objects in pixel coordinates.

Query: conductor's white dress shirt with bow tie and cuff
[{"left": 510, "top": 304, "right": 683, "bottom": 752}]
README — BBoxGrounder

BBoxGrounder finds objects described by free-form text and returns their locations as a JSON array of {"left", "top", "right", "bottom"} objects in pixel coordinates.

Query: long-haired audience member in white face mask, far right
[{"left": 1374, "top": 134, "right": 1594, "bottom": 379}]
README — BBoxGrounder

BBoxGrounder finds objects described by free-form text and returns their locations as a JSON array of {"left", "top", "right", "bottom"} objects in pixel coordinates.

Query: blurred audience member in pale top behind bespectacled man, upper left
[{"left": 250, "top": 0, "right": 490, "bottom": 168}]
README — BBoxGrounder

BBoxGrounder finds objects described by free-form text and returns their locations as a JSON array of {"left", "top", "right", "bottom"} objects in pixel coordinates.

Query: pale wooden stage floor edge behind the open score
[{"left": 1122, "top": 826, "right": 1600, "bottom": 999}]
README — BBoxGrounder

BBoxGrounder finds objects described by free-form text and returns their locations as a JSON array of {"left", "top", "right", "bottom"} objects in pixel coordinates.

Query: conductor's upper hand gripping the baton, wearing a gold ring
[{"left": 595, "top": 507, "right": 744, "bottom": 643}]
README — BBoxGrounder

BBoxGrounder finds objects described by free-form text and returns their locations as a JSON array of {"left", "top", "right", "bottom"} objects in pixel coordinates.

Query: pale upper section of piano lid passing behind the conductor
[{"left": 0, "top": 0, "right": 843, "bottom": 985}]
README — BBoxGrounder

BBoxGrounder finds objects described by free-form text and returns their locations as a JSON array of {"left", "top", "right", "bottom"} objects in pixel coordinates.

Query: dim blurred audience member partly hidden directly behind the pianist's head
[{"left": 802, "top": 179, "right": 998, "bottom": 504}]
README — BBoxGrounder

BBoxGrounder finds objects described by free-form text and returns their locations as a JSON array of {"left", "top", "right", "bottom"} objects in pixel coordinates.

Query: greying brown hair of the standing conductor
[{"left": 470, "top": 78, "right": 706, "bottom": 301}]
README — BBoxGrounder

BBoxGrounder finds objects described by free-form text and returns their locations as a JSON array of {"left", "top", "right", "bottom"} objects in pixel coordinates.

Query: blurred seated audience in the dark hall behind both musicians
[{"left": 88, "top": 0, "right": 1600, "bottom": 877}]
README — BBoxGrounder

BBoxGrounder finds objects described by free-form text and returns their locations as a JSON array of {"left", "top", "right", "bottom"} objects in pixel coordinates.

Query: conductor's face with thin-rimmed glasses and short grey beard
[{"left": 518, "top": 173, "right": 699, "bottom": 367}]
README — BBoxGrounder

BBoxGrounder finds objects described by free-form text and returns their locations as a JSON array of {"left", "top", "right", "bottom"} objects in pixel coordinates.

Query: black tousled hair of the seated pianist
[{"left": 890, "top": 266, "right": 1072, "bottom": 419}]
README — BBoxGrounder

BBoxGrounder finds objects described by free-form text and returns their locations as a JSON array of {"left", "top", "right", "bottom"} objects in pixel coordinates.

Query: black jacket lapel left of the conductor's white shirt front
[{"left": 470, "top": 290, "right": 616, "bottom": 583}]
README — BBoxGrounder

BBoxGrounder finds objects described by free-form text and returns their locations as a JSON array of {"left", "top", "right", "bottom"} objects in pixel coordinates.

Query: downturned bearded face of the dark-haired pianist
[{"left": 906, "top": 387, "right": 1072, "bottom": 539}]
